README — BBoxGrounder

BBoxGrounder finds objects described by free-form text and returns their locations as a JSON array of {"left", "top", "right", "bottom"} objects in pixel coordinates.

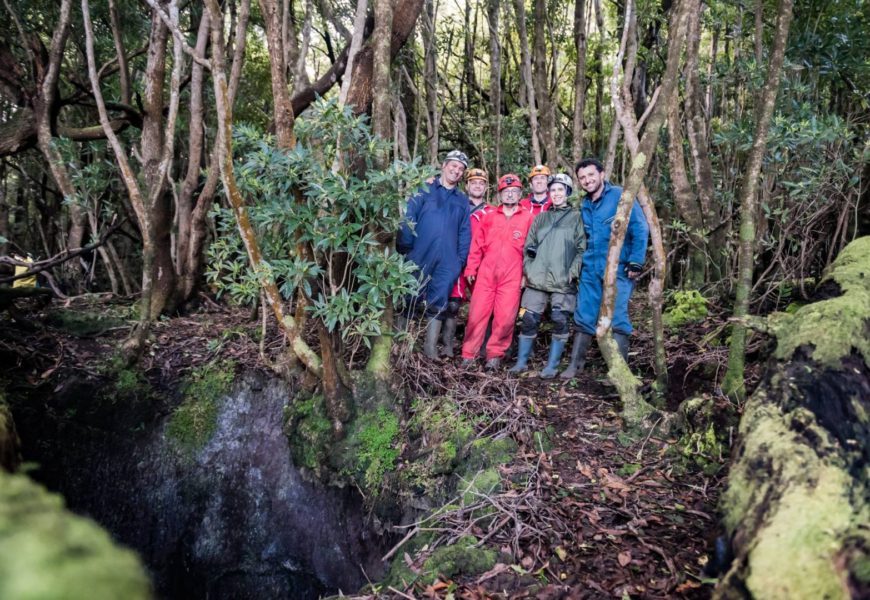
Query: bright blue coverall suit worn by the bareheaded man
[{"left": 574, "top": 181, "right": 649, "bottom": 335}]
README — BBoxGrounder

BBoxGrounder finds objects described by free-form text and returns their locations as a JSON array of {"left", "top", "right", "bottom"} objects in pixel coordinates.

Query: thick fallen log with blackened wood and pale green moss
[{"left": 714, "top": 237, "right": 870, "bottom": 598}]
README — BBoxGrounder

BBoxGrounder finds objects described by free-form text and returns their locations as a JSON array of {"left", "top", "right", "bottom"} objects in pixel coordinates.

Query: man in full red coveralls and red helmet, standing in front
[{"left": 462, "top": 174, "right": 534, "bottom": 370}]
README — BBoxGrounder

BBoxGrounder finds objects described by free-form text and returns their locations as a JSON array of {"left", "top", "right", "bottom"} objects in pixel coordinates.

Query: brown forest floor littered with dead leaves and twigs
[{"left": 0, "top": 300, "right": 752, "bottom": 598}]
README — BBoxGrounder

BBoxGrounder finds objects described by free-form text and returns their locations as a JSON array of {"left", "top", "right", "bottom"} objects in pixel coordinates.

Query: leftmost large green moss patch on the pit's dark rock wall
[{"left": 166, "top": 361, "right": 236, "bottom": 452}]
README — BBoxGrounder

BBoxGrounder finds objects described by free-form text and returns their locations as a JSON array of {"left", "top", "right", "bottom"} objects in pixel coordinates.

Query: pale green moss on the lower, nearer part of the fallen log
[{"left": 721, "top": 392, "right": 870, "bottom": 598}]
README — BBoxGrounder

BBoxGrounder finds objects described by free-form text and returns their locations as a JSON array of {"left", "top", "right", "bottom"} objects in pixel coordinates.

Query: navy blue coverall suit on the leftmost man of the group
[{"left": 396, "top": 177, "right": 471, "bottom": 318}]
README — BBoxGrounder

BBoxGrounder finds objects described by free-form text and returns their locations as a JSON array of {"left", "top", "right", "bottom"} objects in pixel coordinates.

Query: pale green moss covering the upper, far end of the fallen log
[{"left": 768, "top": 236, "right": 870, "bottom": 367}]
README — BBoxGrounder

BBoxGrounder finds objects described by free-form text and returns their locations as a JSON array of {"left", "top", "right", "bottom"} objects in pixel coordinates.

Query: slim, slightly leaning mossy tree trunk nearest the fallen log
[{"left": 722, "top": 0, "right": 793, "bottom": 400}]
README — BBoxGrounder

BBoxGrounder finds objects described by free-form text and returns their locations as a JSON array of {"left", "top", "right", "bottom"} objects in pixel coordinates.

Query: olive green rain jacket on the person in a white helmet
[{"left": 523, "top": 203, "right": 586, "bottom": 294}]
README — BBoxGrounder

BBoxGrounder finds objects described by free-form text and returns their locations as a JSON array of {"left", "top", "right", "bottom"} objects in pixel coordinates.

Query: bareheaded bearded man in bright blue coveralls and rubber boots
[{"left": 560, "top": 158, "right": 649, "bottom": 379}]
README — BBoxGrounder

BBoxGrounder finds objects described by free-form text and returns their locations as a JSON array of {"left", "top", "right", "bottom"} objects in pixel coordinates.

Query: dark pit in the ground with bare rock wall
[{"left": 8, "top": 374, "right": 389, "bottom": 599}]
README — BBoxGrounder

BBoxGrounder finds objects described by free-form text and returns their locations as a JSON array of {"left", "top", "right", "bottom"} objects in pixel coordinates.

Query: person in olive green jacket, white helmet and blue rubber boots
[{"left": 510, "top": 173, "right": 586, "bottom": 379}]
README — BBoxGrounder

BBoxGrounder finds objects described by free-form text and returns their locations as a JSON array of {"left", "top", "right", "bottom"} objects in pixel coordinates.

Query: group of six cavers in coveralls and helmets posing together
[{"left": 396, "top": 150, "right": 649, "bottom": 379}]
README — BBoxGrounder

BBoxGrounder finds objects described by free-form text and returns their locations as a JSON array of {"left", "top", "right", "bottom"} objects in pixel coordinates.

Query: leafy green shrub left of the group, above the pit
[{"left": 206, "top": 100, "right": 432, "bottom": 345}]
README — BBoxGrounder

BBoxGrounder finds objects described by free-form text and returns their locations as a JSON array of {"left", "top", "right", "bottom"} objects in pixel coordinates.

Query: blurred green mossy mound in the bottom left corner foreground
[{"left": 0, "top": 472, "right": 151, "bottom": 600}]
